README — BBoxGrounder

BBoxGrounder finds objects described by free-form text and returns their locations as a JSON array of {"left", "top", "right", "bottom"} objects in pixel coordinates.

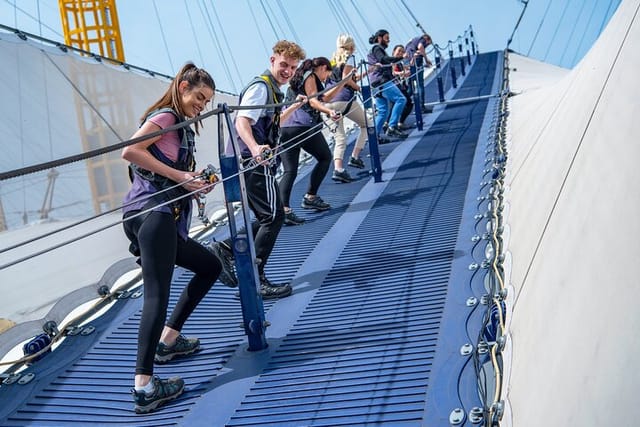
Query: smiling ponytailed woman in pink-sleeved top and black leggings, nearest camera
[{"left": 122, "top": 63, "right": 222, "bottom": 413}]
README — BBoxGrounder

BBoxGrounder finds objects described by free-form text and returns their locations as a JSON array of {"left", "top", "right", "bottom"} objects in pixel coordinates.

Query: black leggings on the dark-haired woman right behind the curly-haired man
[{"left": 280, "top": 126, "right": 332, "bottom": 207}]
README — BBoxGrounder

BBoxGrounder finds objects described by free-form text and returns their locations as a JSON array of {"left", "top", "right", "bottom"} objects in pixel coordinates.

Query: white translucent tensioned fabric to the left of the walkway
[{"left": 0, "top": 33, "right": 236, "bottom": 336}]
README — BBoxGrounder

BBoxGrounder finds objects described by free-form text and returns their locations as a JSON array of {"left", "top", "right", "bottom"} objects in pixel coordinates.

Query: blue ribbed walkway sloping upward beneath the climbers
[{"left": 0, "top": 53, "right": 500, "bottom": 426}]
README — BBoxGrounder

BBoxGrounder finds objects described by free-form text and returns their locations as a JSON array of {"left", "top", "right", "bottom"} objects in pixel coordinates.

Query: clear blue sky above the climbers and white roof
[{"left": 0, "top": 0, "right": 620, "bottom": 93}]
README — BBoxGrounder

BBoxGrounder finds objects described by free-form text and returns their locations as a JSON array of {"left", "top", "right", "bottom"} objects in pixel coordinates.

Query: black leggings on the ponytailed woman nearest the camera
[{"left": 124, "top": 212, "right": 222, "bottom": 375}]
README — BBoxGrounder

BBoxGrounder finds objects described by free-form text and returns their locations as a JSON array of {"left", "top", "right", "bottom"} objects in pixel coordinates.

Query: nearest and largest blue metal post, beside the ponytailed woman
[{"left": 218, "top": 104, "right": 268, "bottom": 351}]
